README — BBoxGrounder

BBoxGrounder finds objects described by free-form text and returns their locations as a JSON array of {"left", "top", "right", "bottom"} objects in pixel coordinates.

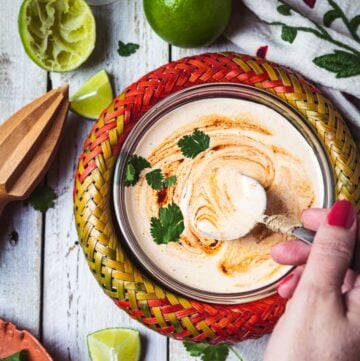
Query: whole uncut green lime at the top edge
[{"left": 144, "top": 0, "right": 232, "bottom": 48}]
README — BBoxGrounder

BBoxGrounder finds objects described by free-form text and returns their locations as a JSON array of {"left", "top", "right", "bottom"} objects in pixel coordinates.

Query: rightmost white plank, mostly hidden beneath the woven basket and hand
[{"left": 169, "top": 37, "right": 268, "bottom": 361}]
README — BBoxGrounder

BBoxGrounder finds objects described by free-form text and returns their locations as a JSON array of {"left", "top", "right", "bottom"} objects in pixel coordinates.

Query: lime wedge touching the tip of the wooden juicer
[{"left": 70, "top": 70, "right": 113, "bottom": 119}]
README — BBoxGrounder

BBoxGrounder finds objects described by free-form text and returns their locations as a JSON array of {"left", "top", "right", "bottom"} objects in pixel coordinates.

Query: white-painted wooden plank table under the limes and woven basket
[{"left": 0, "top": 0, "right": 267, "bottom": 361}]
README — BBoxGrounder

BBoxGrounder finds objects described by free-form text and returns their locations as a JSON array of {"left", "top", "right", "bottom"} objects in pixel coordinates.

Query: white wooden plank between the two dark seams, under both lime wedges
[{"left": 43, "top": 0, "right": 168, "bottom": 361}]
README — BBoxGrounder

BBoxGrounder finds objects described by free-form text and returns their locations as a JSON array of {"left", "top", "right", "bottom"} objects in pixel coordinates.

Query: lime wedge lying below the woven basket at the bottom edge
[{"left": 87, "top": 328, "right": 141, "bottom": 361}]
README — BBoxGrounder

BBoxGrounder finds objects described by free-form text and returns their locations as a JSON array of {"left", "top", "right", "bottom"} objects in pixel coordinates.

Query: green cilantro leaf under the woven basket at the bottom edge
[{"left": 184, "top": 341, "right": 229, "bottom": 361}]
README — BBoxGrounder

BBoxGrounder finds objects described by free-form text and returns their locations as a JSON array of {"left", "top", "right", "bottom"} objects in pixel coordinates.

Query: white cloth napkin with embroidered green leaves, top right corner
[{"left": 225, "top": 0, "right": 360, "bottom": 139}]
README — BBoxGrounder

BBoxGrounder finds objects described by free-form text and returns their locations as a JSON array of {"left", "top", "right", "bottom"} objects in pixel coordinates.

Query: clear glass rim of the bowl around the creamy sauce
[{"left": 113, "top": 83, "right": 335, "bottom": 304}]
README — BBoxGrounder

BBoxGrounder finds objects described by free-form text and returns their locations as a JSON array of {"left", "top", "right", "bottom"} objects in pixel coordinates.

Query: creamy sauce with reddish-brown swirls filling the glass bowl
[{"left": 125, "top": 98, "right": 323, "bottom": 293}]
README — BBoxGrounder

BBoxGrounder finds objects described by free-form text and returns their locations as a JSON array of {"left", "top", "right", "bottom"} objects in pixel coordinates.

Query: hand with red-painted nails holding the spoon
[{"left": 264, "top": 201, "right": 360, "bottom": 361}]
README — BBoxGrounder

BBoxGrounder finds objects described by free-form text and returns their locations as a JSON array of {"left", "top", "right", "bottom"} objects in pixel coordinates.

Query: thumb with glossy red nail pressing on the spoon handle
[{"left": 301, "top": 200, "right": 356, "bottom": 293}]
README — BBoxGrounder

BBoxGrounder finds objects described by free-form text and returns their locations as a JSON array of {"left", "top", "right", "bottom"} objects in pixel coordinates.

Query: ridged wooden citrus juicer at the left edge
[{"left": 0, "top": 85, "right": 69, "bottom": 215}]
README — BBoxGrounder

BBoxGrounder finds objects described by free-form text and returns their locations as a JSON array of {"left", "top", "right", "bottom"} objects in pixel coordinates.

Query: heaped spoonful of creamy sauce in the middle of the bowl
[{"left": 195, "top": 172, "right": 266, "bottom": 241}]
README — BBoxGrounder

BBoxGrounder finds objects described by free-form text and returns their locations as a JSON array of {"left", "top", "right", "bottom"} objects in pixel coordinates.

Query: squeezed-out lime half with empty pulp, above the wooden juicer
[{"left": 18, "top": 0, "right": 96, "bottom": 72}]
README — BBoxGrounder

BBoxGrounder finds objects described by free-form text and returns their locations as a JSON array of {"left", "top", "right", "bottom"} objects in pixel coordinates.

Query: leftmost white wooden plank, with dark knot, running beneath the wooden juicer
[{"left": 0, "top": 0, "right": 47, "bottom": 335}]
